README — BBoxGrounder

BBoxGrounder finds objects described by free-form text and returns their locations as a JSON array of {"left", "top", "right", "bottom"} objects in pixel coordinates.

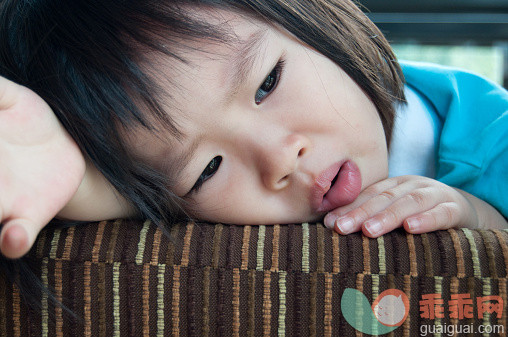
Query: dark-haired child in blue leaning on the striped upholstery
[{"left": 0, "top": 0, "right": 508, "bottom": 258}]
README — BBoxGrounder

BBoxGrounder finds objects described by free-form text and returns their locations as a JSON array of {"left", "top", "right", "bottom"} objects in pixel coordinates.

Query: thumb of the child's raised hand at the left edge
[{"left": 0, "top": 219, "right": 44, "bottom": 259}]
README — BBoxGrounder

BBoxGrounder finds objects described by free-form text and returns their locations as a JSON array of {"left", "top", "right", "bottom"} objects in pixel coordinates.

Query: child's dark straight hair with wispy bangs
[{"left": 0, "top": 0, "right": 403, "bottom": 310}]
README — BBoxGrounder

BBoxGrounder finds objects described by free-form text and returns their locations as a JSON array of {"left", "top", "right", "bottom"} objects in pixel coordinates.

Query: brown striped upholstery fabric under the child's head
[{"left": 0, "top": 221, "right": 508, "bottom": 337}]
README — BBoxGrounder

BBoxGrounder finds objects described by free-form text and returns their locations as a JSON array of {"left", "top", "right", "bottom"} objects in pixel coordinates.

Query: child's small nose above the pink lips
[{"left": 259, "top": 134, "right": 310, "bottom": 191}]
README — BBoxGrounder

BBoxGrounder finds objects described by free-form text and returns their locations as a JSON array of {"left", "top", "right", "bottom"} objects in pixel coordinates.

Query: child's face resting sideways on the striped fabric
[{"left": 130, "top": 12, "right": 388, "bottom": 224}]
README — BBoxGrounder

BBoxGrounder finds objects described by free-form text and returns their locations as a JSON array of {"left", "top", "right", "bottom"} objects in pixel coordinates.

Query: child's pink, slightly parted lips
[{"left": 312, "top": 160, "right": 362, "bottom": 212}]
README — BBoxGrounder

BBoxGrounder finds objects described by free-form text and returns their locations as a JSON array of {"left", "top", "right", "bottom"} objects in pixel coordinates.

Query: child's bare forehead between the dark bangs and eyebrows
[{"left": 157, "top": 10, "right": 275, "bottom": 113}]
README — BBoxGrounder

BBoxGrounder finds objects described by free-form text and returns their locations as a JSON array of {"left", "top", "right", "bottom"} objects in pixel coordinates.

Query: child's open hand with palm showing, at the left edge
[{"left": 0, "top": 77, "right": 86, "bottom": 258}]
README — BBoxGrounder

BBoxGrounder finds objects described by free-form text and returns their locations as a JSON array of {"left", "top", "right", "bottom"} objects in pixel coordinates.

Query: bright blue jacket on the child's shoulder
[{"left": 401, "top": 62, "right": 508, "bottom": 218}]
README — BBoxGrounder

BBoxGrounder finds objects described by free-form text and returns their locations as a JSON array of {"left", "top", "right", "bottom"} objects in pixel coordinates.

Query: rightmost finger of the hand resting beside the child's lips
[{"left": 404, "top": 202, "right": 461, "bottom": 234}]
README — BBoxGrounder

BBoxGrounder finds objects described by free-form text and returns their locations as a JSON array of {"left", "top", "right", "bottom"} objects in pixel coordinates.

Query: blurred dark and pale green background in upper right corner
[{"left": 354, "top": 0, "right": 508, "bottom": 88}]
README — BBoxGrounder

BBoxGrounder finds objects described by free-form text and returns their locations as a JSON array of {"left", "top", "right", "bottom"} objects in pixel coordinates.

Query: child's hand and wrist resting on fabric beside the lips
[{"left": 325, "top": 176, "right": 508, "bottom": 237}]
